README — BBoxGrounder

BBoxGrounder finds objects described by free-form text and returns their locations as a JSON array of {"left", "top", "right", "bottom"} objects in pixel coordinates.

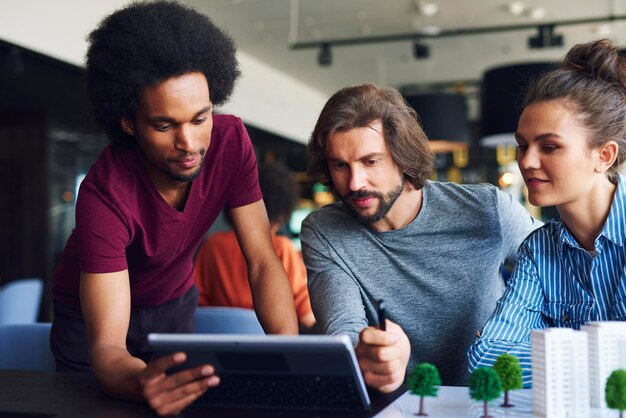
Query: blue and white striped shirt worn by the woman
[{"left": 467, "top": 175, "right": 626, "bottom": 387}]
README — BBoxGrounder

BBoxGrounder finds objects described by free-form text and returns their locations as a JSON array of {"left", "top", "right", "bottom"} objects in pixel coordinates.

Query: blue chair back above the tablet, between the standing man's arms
[{"left": 194, "top": 306, "right": 265, "bottom": 335}]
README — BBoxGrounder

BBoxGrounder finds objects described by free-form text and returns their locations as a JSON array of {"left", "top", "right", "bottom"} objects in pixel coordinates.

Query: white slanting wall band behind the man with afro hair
[{"left": 0, "top": 0, "right": 327, "bottom": 143}]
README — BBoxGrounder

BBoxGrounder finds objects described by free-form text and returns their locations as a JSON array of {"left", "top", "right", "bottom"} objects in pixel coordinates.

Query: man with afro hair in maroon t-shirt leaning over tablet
[{"left": 51, "top": 1, "right": 298, "bottom": 415}]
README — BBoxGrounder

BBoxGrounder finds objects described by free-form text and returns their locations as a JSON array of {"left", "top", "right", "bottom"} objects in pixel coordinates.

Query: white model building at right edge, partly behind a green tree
[{"left": 580, "top": 321, "right": 626, "bottom": 408}]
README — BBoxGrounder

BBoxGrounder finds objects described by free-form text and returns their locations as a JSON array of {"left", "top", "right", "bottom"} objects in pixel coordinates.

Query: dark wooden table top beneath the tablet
[{"left": 0, "top": 370, "right": 405, "bottom": 418}]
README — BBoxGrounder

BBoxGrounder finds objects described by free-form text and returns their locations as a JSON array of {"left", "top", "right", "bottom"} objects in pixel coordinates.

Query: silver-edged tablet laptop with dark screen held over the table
[{"left": 148, "top": 334, "right": 371, "bottom": 411}]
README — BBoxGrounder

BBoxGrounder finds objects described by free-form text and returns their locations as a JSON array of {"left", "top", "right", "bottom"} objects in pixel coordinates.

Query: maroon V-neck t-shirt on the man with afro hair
[{"left": 53, "top": 115, "right": 262, "bottom": 308}]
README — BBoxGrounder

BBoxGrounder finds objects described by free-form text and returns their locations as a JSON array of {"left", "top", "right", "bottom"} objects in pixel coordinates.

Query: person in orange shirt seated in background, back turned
[{"left": 194, "top": 164, "right": 315, "bottom": 329}]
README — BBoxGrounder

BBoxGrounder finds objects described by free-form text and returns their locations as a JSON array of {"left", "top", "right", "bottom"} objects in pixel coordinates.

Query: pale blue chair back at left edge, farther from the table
[{"left": 0, "top": 278, "right": 43, "bottom": 325}]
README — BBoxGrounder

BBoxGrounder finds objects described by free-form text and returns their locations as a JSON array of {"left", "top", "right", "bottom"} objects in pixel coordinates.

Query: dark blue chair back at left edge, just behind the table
[{"left": 0, "top": 322, "right": 55, "bottom": 371}]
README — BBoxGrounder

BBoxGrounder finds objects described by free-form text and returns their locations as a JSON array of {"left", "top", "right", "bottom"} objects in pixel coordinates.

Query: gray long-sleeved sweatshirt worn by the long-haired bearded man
[{"left": 300, "top": 182, "right": 540, "bottom": 385}]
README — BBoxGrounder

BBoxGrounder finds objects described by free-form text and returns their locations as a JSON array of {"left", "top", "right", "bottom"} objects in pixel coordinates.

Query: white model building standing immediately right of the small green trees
[{"left": 531, "top": 328, "right": 591, "bottom": 418}]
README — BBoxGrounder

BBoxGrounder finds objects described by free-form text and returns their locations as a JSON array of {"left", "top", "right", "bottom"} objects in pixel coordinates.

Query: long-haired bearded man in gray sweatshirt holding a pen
[{"left": 301, "top": 84, "right": 539, "bottom": 392}]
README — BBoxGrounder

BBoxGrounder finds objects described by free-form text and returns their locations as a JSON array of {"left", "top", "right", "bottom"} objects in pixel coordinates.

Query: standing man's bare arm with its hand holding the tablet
[{"left": 80, "top": 270, "right": 219, "bottom": 415}]
